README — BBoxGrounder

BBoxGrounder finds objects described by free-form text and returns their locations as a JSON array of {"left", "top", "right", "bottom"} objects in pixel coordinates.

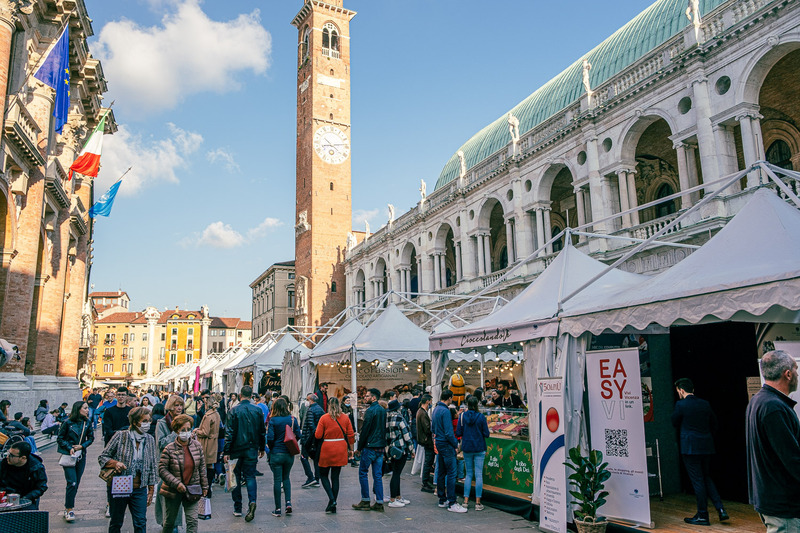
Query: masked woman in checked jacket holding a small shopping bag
[{"left": 98, "top": 407, "right": 158, "bottom": 533}]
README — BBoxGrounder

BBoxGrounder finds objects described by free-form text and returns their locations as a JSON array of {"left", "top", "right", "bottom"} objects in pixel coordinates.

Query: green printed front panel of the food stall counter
[{"left": 483, "top": 437, "right": 533, "bottom": 495}]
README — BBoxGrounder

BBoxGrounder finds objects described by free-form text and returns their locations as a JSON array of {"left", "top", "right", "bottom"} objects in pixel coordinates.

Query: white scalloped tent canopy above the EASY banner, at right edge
[{"left": 562, "top": 188, "right": 800, "bottom": 336}]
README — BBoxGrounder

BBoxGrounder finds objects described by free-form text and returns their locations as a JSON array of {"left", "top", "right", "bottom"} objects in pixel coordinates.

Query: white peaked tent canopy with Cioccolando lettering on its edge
[{"left": 430, "top": 240, "right": 649, "bottom": 351}]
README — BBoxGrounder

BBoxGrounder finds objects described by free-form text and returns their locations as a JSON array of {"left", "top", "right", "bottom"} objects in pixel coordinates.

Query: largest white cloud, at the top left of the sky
[{"left": 92, "top": 0, "right": 272, "bottom": 115}]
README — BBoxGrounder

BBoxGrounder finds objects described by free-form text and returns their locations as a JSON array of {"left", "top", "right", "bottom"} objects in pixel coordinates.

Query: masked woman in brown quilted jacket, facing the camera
[{"left": 158, "top": 415, "right": 208, "bottom": 533}]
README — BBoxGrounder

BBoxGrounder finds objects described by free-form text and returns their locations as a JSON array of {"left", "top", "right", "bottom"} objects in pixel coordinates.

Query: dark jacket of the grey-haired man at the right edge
[{"left": 747, "top": 385, "right": 800, "bottom": 518}]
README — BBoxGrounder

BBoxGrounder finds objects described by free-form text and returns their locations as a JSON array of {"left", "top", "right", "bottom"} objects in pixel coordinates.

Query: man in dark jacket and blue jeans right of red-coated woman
[{"left": 353, "top": 389, "right": 386, "bottom": 512}]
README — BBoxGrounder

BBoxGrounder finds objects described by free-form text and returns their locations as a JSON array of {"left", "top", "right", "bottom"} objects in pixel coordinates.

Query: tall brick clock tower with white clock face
[{"left": 292, "top": 0, "right": 356, "bottom": 326}]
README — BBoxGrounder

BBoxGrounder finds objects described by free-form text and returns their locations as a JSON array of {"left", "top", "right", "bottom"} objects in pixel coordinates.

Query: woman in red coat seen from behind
[{"left": 314, "top": 398, "right": 354, "bottom": 514}]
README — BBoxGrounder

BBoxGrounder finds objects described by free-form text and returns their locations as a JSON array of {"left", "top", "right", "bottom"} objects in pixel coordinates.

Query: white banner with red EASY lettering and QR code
[{"left": 586, "top": 348, "right": 650, "bottom": 524}]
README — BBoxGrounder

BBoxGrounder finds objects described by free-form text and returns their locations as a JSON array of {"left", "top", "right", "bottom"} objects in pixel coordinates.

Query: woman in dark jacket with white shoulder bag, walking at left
[{"left": 57, "top": 401, "right": 94, "bottom": 522}]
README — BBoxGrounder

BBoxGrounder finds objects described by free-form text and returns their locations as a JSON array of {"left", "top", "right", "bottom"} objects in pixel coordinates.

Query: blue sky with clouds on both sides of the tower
[{"left": 86, "top": 0, "right": 649, "bottom": 320}]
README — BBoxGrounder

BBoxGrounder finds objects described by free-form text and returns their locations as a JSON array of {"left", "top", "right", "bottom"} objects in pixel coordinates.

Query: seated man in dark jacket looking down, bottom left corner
[{"left": 0, "top": 442, "right": 47, "bottom": 511}]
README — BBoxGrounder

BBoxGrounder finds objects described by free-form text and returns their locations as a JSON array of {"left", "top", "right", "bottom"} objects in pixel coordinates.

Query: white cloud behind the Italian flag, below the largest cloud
[{"left": 100, "top": 123, "right": 203, "bottom": 195}]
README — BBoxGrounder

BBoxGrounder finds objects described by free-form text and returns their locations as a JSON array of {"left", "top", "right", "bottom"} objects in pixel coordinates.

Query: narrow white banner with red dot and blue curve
[{"left": 537, "top": 378, "right": 569, "bottom": 533}]
